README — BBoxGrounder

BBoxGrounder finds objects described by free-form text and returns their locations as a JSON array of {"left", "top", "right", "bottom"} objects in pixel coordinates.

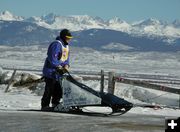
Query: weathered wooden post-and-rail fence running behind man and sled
[{"left": 3, "top": 68, "right": 180, "bottom": 107}]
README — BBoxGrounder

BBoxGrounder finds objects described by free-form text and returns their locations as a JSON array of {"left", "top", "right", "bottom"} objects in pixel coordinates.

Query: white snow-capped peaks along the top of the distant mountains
[{"left": 0, "top": 11, "right": 180, "bottom": 40}]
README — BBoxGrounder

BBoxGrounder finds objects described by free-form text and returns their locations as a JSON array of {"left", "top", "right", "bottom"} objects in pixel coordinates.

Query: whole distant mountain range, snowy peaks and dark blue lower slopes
[{"left": 0, "top": 11, "right": 180, "bottom": 50}]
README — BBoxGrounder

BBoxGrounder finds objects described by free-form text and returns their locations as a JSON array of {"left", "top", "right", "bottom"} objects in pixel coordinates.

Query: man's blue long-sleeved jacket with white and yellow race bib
[{"left": 43, "top": 39, "right": 69, "bottom": 81}]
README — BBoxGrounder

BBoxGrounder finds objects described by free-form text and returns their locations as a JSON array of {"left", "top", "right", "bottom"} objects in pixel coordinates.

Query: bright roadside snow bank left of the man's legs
[{"left": 0, "top": 85, "right": 41, "bottom": 110}]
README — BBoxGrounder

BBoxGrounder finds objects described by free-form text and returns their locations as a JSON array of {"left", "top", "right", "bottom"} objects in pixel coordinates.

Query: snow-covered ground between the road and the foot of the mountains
[{"left": 0, "top": 46, "right": 180, "bottom": 116}]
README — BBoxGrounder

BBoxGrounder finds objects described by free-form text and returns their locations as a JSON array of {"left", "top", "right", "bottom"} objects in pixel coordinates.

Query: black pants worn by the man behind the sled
[{"left": 41, "top": 78, "right": 62, "bottom": 107}]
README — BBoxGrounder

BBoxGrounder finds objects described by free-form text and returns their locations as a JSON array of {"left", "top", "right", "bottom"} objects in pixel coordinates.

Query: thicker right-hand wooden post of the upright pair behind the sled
[{"left": 108, "top": 72, "right": 115, "bottom": 94}]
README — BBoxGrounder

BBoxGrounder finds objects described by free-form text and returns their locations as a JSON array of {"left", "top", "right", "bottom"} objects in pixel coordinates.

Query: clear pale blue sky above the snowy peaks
[{"left": 0, "top": 0, "right": 180, "bottom": 22}]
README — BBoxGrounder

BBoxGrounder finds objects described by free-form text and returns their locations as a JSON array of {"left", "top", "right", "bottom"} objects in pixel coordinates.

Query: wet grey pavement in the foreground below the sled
[{"left": 0, "top": 111, "right": 165, "bottom": 132}]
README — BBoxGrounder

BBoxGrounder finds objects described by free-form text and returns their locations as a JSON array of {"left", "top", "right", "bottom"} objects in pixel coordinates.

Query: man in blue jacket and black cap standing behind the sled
[{"left": 41, "top": 29, "right": 72, "bottom": 110}]
